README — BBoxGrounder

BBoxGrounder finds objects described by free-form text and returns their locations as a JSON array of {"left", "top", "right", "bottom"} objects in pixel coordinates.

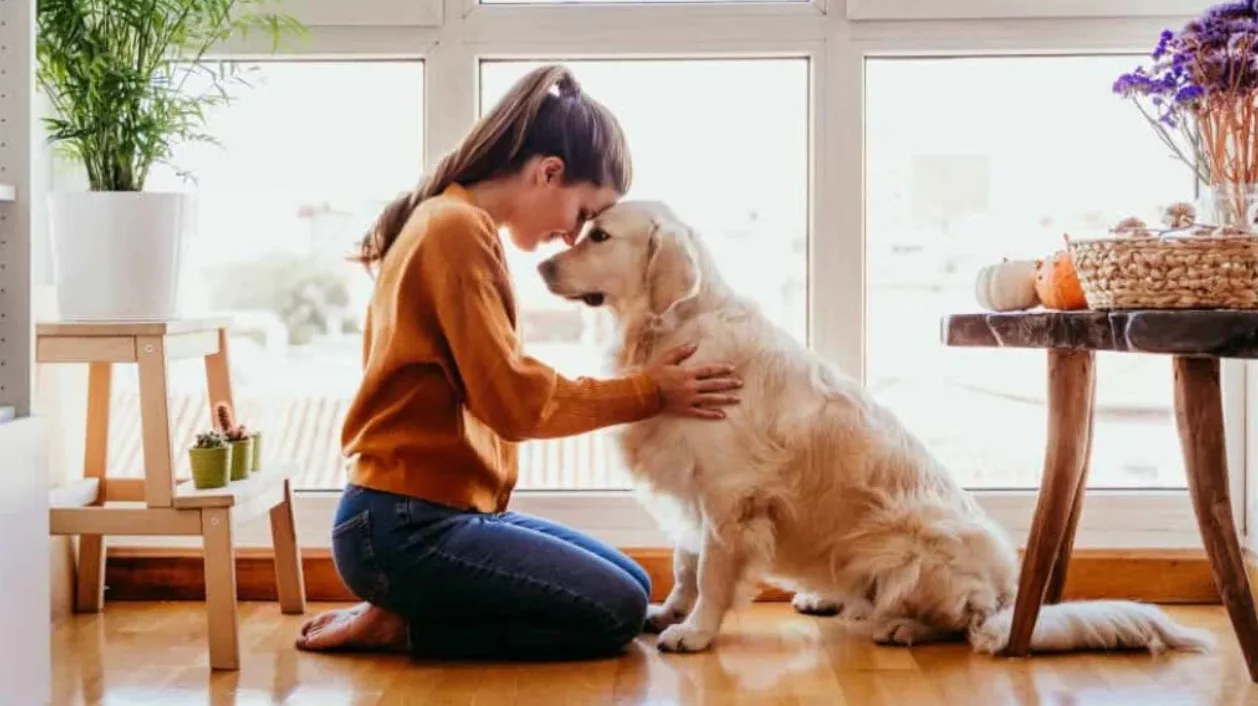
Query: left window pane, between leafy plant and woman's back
[{"left": 101, "top": 62, "right": 424, "bottom": 490}]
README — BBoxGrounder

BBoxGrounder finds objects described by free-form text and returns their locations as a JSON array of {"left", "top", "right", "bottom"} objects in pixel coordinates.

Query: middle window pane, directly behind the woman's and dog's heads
[{"left": 481, "top": 59, "right": 809, "bottom": 490}]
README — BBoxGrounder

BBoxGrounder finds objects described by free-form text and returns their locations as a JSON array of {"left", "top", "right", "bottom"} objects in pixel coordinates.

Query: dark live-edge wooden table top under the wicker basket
[{"left": 941, "top": 310, "right": 1258, "bottom": 359}]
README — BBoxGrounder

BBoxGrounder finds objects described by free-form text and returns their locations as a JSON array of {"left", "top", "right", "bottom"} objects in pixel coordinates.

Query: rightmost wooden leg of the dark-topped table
[{"left": 1175, "top": 356, "right": 1258, "bottom": 682}]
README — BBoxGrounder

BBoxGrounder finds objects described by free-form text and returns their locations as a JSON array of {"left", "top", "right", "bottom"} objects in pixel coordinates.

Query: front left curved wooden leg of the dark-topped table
[{"left": 1004, "top": 350, "right": 1096, "bottom": 657}]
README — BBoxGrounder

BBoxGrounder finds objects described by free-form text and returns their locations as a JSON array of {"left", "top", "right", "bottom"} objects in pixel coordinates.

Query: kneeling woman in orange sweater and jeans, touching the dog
[{"left": 297, "top": 65, "right": 741, "bottom": 659}]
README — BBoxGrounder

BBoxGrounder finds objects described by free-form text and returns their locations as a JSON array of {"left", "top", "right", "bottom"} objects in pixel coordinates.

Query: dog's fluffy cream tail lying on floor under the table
[{"left": 969, "top": 600, "right": 1214, "bottom": 654}]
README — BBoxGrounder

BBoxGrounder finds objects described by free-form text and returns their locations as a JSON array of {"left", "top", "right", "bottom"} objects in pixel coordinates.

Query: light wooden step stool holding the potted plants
[{"left": 35, "top": 320, "right": 306, "bottom": 670}]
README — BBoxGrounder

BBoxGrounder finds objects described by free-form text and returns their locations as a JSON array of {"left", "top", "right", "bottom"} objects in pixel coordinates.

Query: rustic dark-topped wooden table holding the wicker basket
[{"left": 942, "top": 311, "right": 1258, "bottom": 682}]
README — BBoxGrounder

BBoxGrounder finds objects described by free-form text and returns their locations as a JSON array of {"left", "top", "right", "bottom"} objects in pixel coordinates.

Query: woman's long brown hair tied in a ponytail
[{"left": 352, "top": 64, "right": 633, "bottom": 268}]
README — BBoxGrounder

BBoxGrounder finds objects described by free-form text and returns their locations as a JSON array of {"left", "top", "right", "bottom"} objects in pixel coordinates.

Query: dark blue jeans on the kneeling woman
[{"left": 332, "top": 485, "right": 650, "bottom": 659}]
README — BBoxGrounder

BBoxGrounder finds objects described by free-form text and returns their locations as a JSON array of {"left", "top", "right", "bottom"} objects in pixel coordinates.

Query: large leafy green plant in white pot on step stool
[{"left": 35, "top": 0, "right": 302, "bottom": 321}]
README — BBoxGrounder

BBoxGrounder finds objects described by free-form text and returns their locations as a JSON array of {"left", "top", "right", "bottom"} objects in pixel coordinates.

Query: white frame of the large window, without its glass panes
[{"left": 91, "top": 0, "right": 1249, "bottom": 547}]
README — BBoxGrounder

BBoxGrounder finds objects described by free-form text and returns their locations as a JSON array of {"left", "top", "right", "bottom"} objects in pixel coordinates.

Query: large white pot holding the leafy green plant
[{"left": 48, "top": 191, "right": 194, "bottom": 321}]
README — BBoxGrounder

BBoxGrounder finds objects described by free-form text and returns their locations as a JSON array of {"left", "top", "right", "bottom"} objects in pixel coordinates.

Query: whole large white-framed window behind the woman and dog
[{"left": 27, "top": 0, "right": 1237, "bottom": 547}]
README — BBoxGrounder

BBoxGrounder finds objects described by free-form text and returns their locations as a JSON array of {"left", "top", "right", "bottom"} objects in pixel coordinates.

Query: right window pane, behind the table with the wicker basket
[{"left": 866, "top": 57, "right": 1194, "bottom": 488}]
